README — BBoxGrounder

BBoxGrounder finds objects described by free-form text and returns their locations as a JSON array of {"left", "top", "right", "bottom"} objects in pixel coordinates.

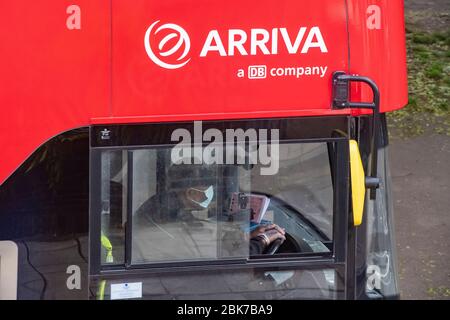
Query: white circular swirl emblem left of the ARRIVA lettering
[{"left": 144, "top": 20, "right": 191, "bottom": 69}]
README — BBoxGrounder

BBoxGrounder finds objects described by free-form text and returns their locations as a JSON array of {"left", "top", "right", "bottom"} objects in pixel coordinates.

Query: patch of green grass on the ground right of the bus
[{"left": 388, "top": 26, "right": 450, "bottom": 136}]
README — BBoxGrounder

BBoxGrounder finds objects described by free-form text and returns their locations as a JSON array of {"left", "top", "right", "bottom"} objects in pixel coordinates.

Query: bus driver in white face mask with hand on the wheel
[{"left": 133, "top": 160, "right": 285, "bottom": 260}]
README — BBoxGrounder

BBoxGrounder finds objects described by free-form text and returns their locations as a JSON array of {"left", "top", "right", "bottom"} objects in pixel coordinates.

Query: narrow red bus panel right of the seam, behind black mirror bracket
[{"left": 348, "top": 0, "right": 408, "bottom": 114}]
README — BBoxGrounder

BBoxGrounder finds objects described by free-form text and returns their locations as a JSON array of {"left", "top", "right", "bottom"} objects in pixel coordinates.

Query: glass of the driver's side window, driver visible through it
[{"left": 101, "top": 143, "right": 333, "bottom": 264}]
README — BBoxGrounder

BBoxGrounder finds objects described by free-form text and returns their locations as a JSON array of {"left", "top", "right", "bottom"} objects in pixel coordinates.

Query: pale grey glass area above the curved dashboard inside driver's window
[{"left": 251, "top": 143, "right": 333, "bottom": 239}]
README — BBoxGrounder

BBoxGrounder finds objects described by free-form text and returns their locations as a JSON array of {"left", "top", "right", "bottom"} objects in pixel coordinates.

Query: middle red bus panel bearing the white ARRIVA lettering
[{"left": 107, "top": 0, "right": 348, "bottom": 118}]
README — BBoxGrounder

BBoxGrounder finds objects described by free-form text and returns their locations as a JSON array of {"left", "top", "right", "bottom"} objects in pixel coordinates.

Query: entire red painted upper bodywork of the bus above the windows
[{"left": 0, "top": 0, "right": 407, "bottom": 184}]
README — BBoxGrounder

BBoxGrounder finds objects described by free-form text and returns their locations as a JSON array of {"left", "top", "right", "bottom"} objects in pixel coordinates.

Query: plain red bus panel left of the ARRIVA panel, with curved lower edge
[{"left": 0, "top": 0, "right": 110, "bottom": 185}]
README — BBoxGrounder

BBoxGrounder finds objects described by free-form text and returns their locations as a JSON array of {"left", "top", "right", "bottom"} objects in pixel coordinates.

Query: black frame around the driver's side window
[{"left": 89, "top": 116, "right": 350, "bottom": 282}]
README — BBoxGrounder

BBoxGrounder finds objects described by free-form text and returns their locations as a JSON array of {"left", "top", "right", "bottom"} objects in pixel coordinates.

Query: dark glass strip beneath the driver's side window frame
[{"left": 90, "top": 268, "right": 344, "bottom": 300}]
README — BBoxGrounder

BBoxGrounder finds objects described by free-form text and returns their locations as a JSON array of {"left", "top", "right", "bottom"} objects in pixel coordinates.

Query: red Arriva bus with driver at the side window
[{"left": 0, "top": 0, "right": 407, "bottom": 299}]
